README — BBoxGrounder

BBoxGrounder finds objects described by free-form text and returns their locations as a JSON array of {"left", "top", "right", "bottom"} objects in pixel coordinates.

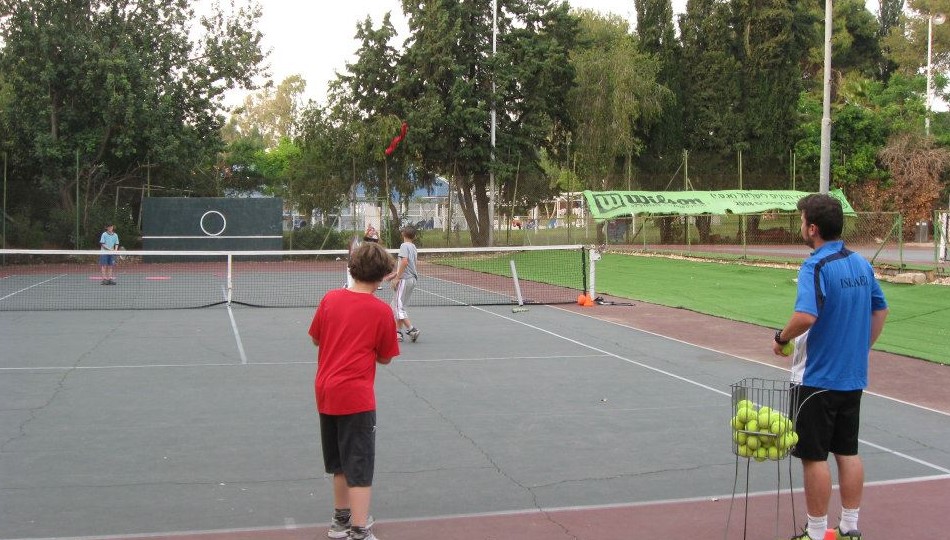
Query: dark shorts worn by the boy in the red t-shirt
[{"left": 320, "top": 411, "right": 376, "bottom": 487}]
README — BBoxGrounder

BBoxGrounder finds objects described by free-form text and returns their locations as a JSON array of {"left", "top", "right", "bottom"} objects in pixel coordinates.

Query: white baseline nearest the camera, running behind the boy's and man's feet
[{"left": 11, "top": 475, "right": 950, "bottom": 540}]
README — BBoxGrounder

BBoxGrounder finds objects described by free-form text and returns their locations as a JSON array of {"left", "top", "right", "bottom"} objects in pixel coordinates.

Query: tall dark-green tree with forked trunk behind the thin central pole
[{"left": 388, "top": 0, "right": 576, "bottom": 245}]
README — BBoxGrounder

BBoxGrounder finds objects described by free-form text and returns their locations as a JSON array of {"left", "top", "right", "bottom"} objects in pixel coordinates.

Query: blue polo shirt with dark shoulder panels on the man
[{"left": 792, "top": 240, "right": 887, "bottom": 391}]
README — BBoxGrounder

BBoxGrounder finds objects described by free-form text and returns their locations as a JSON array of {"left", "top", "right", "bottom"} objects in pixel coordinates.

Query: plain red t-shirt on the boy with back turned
[{"left": 310, "top": 289, "right": 399, "bottom": 415}]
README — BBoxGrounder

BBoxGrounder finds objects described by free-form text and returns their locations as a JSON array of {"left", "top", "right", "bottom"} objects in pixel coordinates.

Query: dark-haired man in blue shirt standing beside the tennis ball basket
[{"left": 772, "top": 194, "right": 887, "bottom": 540}]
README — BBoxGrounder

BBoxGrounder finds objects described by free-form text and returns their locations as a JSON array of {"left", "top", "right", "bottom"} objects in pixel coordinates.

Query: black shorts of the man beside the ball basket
[{"left": 792, "top": 386, "right": 864, "bottom": 461}]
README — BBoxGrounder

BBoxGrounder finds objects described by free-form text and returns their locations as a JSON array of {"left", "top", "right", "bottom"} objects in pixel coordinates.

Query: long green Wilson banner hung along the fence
[{"left": 584, "top": 189, "right": 854, "bottom": 220}]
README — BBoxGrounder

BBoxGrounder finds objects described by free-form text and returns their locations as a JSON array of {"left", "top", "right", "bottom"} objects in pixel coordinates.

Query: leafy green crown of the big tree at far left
[{"left": 0, "top": 0, "right": 262, "bottom": 244}]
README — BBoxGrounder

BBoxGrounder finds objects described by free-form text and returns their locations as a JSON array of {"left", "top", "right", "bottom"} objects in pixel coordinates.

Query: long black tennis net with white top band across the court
[{"left": 0, "top": 245, "right": 591, "bottom": 311}]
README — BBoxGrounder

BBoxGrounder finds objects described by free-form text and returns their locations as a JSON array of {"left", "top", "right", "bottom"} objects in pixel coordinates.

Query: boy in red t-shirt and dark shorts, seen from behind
[{"left": 310, "top": 242, "right": 399, "bottom": 540}]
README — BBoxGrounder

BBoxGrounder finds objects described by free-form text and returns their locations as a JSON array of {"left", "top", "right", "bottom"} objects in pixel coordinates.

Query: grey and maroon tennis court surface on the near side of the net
[{"left": 0, "top": 260, "right": 950, "bottom": 540}]
